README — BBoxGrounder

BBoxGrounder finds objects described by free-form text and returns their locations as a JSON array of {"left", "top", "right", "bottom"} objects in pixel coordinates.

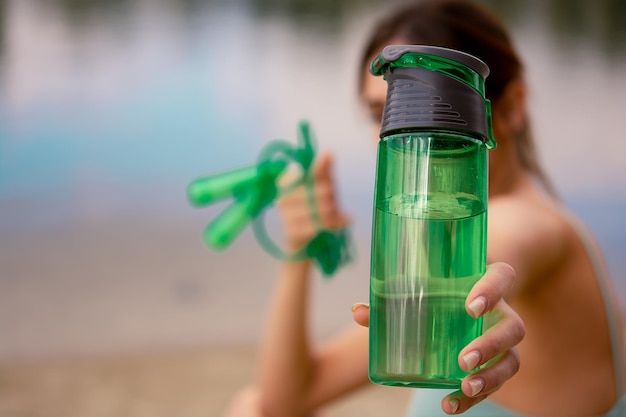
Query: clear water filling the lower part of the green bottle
[{"left": 370, "top": 193, "right": 486, "bottom": 388}]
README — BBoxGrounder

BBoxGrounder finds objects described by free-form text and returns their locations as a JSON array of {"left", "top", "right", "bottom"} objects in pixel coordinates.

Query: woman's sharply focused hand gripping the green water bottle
[{"left": 352, "top": 263, "right": 525, "bottom": 414}]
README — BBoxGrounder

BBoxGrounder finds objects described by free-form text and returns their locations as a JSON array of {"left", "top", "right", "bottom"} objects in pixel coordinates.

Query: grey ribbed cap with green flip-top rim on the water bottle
[{"left": 370, "top": 45, "right": 495, "bottom": 148}]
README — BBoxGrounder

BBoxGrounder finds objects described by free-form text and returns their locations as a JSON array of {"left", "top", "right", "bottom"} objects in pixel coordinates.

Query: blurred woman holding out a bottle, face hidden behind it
[{"left": 222, "top": 0, "right": 626, "bottom": 417}]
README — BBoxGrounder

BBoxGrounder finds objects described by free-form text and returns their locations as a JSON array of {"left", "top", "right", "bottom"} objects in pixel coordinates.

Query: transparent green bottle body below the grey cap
[{"left": 369, "top": 130, "right": 488, "bottom": 388}]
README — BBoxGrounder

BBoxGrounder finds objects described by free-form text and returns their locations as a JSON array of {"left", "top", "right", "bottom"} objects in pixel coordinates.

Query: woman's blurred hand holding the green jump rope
[{"left": 278, "top": 154, "right": 348, "bottom": 251}]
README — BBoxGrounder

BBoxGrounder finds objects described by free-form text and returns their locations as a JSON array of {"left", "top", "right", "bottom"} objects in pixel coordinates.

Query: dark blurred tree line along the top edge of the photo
[{"left": 0, "top": 0, "right": 626, "bottom": 64}]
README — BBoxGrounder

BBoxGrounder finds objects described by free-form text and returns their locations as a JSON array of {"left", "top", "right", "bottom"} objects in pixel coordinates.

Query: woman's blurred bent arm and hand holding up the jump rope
[{"left": 259, "top": 155, "right": 367, "bottom": 417}]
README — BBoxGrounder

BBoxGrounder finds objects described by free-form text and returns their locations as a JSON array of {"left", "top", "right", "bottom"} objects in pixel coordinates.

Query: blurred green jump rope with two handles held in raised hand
[{"left": 187, "top": 121, "right": 353, "bottom": 277}]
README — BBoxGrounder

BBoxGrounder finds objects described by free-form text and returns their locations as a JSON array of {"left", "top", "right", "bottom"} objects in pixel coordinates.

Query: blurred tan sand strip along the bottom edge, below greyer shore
[{"left": 0, "top": 347, "right": 410, "bottom": 417}]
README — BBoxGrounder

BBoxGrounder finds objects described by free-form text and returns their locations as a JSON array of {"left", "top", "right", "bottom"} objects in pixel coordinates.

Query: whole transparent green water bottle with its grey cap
[{"left": 369, "top": 45, "right": 495, "bottom": 388}]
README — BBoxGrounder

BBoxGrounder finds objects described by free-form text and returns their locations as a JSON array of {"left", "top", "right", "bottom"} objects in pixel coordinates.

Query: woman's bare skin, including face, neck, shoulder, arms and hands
[{"left": 221, "top": 46, "right": 616, "bottom": 417}]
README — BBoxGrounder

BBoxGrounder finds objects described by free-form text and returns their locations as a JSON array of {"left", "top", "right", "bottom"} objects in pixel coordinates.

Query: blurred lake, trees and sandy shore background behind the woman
[{"left": 0, "top": 0, "right": 626, "bottom": 417}]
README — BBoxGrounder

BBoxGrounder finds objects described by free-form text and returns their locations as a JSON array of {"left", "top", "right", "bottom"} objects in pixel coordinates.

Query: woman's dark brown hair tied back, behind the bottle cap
[{"left": 359, "top": 0, "right": 556, "bottom": 195}]
